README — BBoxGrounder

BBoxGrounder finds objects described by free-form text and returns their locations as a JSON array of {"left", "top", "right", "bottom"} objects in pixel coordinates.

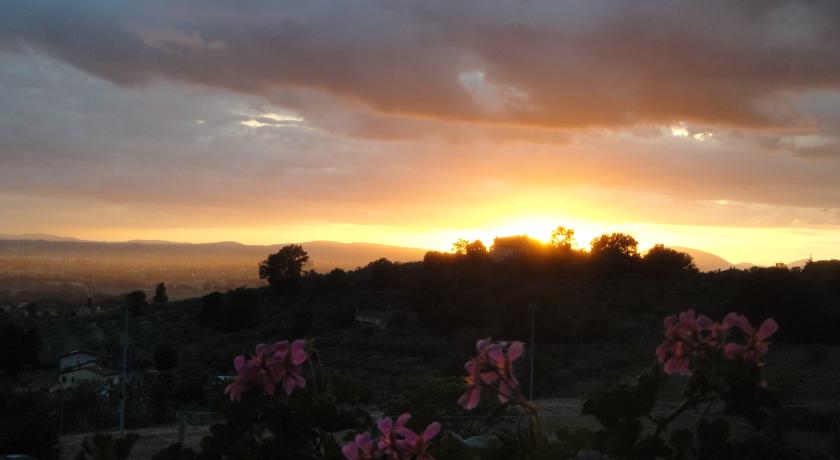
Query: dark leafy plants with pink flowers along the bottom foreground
[{"left": 135, "top": 310, "right": 778, "bottom": 460}]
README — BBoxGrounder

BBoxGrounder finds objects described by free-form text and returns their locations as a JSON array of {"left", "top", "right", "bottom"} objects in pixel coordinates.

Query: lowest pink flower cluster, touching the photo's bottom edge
[{"left": 341, "top": 413, "right": 440, "bottom": 460}]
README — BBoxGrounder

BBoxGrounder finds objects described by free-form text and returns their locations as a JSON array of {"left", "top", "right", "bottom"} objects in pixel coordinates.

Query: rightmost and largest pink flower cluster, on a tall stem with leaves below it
[{"left": 656, "top": 310, "right": 779, "bottom": 375}]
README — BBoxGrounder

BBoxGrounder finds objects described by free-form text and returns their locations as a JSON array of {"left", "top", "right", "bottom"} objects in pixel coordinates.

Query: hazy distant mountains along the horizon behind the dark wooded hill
[{"left": 0, "top": 233, "right": 820, "bottom": 271}]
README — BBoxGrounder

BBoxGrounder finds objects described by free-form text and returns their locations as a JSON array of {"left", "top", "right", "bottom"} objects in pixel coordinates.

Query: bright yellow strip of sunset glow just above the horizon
[{"left": 54, "top": 215, "right": 840, "bottom": 265}]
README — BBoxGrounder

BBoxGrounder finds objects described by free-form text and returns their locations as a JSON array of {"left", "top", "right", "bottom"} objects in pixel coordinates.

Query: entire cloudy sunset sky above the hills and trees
[{"left": 0, "top": 0, "right": 840, "bottom": 264}]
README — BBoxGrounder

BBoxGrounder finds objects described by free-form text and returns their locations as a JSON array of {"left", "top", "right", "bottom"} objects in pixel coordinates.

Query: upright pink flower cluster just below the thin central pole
[{"left": 458, "top": 338, "right": 524, "bottom": 410}]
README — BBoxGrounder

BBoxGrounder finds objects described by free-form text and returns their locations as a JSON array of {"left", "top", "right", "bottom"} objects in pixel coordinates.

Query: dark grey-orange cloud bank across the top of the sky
[{"left": 0, "top": 0, "right": 840, "bottom": 128}]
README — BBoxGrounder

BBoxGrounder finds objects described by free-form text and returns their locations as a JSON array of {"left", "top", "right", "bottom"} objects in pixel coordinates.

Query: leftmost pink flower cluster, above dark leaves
[{"left": 225, "top": 340, "right": 307, "bottom": 401}]
